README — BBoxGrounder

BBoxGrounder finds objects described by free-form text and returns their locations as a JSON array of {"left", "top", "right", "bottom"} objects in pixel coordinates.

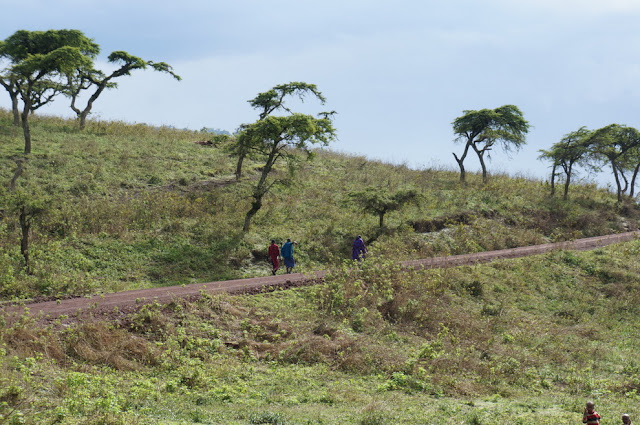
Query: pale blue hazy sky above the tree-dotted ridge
[{"left": 0, "top": 0, "right": 640, "bottom": 186}]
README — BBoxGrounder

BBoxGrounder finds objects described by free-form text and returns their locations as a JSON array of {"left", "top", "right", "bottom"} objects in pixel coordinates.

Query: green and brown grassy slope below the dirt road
[{"left": 0, "top": 240, "right": 640, "bottom": 425}]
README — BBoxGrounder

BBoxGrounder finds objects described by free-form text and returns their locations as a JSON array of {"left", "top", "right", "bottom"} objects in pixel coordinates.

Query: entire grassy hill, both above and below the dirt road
[{"left": 0, "top": 111, "right": 640, "bottom": 425}]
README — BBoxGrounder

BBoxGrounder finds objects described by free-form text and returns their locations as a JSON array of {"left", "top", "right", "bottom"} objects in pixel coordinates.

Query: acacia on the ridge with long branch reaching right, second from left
[{"left": 64, "top": 51, "right": 181, "bottom": 130}]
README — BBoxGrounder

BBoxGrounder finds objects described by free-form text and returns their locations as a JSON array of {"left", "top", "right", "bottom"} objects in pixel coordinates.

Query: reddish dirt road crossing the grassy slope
[{"left": 0, "top": 230, "right": 640, "bottom": 320}]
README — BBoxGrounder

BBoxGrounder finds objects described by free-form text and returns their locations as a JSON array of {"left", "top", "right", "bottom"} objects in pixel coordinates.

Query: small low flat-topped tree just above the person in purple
[{"left": 349, "top": 187, "right": 420, "bottom": 227}]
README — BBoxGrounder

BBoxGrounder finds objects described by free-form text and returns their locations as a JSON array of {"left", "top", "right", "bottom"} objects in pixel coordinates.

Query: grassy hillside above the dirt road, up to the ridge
[{"left": 0, "top": 111, "right": 639, "bottom": 299}]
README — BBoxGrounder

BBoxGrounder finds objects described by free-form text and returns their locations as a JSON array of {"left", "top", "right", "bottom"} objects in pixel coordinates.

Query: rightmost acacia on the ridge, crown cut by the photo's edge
[{"left": 589, "top": 124, "right": 640, "bottom": 202}]
